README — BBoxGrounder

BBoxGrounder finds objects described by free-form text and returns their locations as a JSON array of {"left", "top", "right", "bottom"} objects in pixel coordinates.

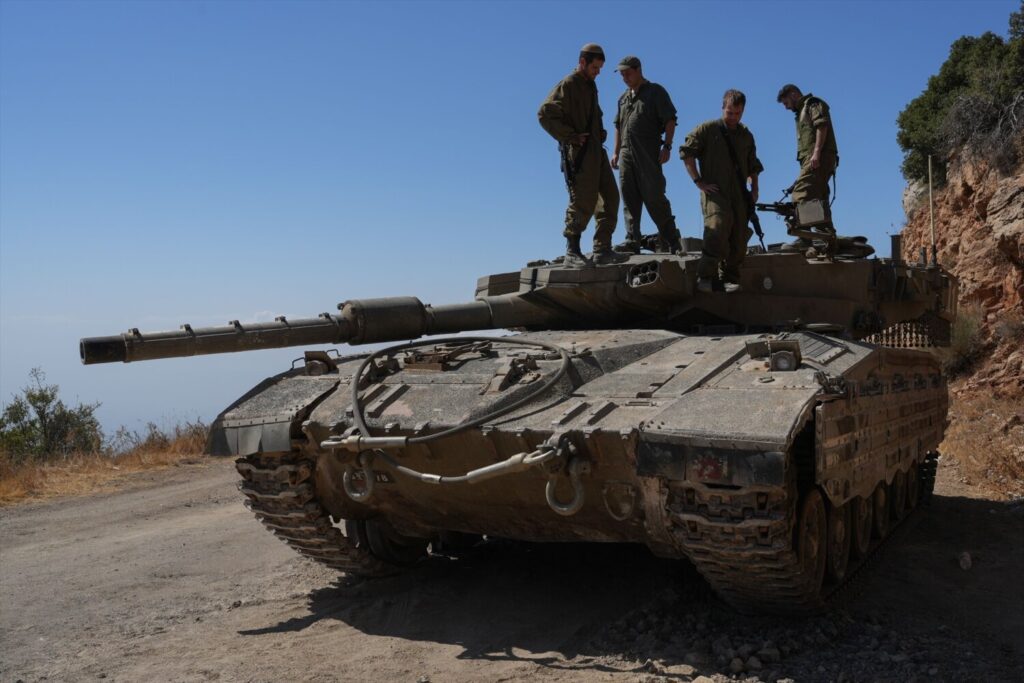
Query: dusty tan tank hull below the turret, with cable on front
[{"left": 222, "top": 330, "right": 947, "bottom": 611}]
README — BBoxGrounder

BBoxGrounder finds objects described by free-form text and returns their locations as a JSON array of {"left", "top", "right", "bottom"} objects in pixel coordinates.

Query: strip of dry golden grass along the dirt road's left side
[{"left": 0, "top": 424, "right": 206, "bottom": 506}]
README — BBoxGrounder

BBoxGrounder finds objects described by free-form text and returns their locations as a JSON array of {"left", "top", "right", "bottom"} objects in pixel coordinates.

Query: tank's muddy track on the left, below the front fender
[{"left": 234, "top": 452, "right": 399, "bottom": 577}]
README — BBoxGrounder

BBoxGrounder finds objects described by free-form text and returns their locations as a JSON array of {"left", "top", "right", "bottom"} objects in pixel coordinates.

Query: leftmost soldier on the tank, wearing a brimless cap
[{"left": 537, "top": 43, "right": 628, "bottom": 265}]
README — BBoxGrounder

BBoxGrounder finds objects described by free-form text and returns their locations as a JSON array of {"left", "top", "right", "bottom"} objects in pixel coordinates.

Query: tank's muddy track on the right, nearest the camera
[{"left": 668, "top": 454, "right": 937, "bottom": 614}]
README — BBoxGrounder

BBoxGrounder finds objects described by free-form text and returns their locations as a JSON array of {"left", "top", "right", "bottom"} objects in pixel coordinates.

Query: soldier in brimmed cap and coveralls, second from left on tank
[{"left": 611, "top": 56, "right": 682, "bottom": 253}]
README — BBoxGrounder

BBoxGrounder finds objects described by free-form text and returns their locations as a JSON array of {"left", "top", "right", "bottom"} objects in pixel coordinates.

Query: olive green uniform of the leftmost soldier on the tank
[{"left": 537, "top": 72, "right": 618, "bottom": 251}]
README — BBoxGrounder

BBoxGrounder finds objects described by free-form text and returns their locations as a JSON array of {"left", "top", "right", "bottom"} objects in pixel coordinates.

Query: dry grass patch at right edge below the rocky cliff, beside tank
[{"left": 940, "top": 385, "right": 1024, "bottom": 498}]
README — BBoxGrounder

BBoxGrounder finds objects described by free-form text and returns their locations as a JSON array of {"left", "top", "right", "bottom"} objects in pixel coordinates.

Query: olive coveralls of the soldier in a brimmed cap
[{"left": 615, "top": 81, "right": 679, "bottom": 244}]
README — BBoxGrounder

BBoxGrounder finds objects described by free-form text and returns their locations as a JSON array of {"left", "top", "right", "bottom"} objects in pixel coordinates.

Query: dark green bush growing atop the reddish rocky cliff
[{"left": 896, "top": 1, "right": 1024, "bottom": 185}]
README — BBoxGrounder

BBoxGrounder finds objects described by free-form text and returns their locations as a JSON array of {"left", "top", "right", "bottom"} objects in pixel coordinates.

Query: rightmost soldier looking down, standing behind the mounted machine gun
[{"left": 776, "top": 83, "right": 839, "bottom": 251}]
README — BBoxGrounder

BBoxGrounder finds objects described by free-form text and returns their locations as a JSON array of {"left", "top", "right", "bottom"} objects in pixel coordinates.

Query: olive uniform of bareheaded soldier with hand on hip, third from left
[{"left": 679, "top": 119, "right": 764, "bottom": 283}]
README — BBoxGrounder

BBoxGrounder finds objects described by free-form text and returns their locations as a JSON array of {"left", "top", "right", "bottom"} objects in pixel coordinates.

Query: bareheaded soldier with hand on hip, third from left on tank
[{"left": 679, "top": 90, "right": 764, "bottom": 292}]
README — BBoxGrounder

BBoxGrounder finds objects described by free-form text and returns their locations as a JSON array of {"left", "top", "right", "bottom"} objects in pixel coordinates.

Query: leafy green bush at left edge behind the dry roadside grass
[{"left": 0, "top": 368, "right": 103, "bottom": 461}]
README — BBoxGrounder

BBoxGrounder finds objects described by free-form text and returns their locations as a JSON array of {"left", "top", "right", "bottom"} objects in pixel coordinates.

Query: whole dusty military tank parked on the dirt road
[{"left": 80, "top": 240, "right": 956, "bottom": 613}]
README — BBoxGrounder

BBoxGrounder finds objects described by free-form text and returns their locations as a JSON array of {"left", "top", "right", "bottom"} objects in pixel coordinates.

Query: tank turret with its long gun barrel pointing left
[{"left": 80, "top": 249, "right": 956, "bottom": 365}]
